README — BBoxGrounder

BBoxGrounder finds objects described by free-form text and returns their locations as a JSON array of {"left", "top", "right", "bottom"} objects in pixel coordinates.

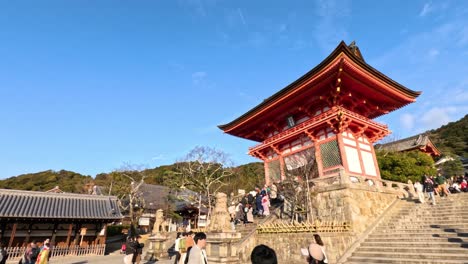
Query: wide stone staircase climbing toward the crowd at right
[{"left": 345, "top": 193, "right": 468, "bottom": 264}]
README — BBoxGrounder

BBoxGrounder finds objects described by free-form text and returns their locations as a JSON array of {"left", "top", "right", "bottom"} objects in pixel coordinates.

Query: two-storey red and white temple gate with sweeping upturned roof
[{"left": 219, "top": 42, "right": 421, "bottom": 183}]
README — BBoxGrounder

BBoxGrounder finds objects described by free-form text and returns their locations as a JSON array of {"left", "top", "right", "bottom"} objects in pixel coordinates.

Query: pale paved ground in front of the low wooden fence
[{"left": 49, "top": 255, "right": 174, "bottom": 264}]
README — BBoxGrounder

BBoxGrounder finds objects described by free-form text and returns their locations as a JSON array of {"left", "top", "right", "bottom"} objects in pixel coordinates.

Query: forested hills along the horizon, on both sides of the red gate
[{"left": 0, "top": 115, "right": 468, "bottom": 193}]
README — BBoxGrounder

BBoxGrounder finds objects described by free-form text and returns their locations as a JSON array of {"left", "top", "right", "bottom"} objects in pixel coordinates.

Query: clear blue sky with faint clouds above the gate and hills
[{"left": 0, "top": 0, "right": 468, "bottom": 178}]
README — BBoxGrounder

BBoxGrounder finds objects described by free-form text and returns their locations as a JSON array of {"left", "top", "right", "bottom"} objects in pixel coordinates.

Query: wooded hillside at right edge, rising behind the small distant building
[{"left": 428, "top": 115, "right": 468, "bottom": 157}]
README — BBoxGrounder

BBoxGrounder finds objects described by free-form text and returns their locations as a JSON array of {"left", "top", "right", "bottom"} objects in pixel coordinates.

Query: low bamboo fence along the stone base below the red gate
[{"left": 257, "top": 221, "right": 351, "bottom": 234}]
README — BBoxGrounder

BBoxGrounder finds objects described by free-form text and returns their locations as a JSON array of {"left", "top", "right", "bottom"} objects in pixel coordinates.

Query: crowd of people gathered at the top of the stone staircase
[{"left": 414, "top": 173, "right": 468, "bottom": 205}]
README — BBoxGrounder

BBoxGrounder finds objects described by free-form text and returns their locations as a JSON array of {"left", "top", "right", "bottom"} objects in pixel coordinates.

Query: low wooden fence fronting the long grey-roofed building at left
[{"left": 6, "top": 244, "right": 106, "bottom": 260}]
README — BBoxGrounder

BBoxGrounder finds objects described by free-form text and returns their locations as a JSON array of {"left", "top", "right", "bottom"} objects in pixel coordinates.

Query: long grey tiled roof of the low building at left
[{"left": 0, "top": 189, "right": 122, "bottom": 220}]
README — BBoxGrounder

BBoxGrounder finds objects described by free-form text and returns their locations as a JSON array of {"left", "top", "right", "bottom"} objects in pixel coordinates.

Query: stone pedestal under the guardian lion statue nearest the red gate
[{"left": 206, "top": 232, "right": 241, "bottom": 263}]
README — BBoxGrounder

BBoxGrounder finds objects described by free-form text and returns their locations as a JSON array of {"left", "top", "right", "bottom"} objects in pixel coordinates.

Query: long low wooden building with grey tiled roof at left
[{"left": 0, "top": 189, "right": 122, "bottom": 247}]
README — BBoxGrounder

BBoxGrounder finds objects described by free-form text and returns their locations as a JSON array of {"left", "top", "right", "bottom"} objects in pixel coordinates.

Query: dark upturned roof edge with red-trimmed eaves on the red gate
[{"left": 218, "top": 41, "right": 421, "bottom": 141}]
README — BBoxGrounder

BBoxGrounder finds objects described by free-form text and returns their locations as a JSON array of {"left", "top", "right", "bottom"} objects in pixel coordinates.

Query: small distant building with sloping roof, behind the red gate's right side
[{"left": 375, "top": 134, "right": 440, "bottom": 157}]
